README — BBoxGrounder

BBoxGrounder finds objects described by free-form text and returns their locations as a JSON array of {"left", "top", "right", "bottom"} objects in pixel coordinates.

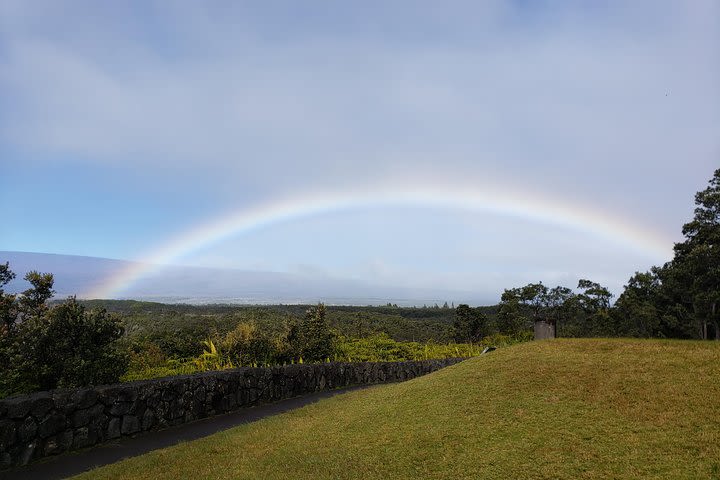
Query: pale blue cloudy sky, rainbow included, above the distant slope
[{"left": 0, "top": 0, "right": 720, "bottom": 304}]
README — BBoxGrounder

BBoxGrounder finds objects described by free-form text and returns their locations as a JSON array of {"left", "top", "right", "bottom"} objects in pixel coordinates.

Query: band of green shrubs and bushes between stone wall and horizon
[{"left": 0, "top": 274, "right": 531, "bottom": 397}]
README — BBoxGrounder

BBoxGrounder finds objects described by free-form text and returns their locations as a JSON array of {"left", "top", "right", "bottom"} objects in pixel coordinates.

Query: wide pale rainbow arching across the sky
[{"left": 83, "top": 182, "right": 673, "bottom": 298}]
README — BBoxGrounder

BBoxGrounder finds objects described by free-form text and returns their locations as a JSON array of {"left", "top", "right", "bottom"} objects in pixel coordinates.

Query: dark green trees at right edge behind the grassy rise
[{"left": 455, "top": 169, "right": 720, "bottom": 341}]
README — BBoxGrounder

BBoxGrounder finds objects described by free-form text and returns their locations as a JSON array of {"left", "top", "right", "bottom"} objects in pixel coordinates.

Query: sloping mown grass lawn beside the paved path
[{"left": 73, "top": 340, "right": 720, "bottom": 480}]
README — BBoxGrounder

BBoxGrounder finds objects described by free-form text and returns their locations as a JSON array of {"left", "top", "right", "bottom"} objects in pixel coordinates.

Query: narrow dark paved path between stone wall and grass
[{"left": 0, "top": 385, "right": 370, "bottom": 480}]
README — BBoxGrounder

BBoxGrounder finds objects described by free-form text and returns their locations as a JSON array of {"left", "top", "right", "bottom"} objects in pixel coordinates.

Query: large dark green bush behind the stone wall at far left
[{"left": 0, "top": 263, "right": 127, "bottom": 396}]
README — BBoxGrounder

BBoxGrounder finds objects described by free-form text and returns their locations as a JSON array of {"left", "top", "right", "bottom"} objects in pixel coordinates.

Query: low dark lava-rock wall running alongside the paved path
[{"left": 0, "top": 359, "right": 462, "bottom": 469}]
